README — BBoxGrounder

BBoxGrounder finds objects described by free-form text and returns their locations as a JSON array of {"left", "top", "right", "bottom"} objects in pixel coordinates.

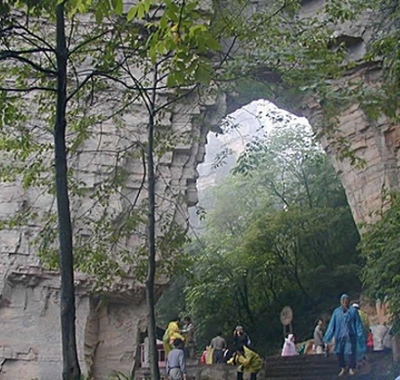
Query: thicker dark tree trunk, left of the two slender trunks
[{"left": 54, "top": 3, "right": 81, "bottom": 380}]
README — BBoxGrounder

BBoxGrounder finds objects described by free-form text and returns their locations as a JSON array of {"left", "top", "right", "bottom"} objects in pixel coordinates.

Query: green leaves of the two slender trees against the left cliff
[{"left": 0, "top": 0, "right": 219, "bottom": 288}]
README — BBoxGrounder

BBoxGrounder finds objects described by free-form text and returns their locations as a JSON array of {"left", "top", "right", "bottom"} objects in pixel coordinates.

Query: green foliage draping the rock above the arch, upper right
[{"left": 213, "top": 0, "right": 400, "bottom": 163}]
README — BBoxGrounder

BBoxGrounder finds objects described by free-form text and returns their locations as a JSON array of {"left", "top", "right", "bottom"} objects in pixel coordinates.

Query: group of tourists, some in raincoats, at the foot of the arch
[{"left": 163, "top": 294, "right": 388, "bottom": 380}]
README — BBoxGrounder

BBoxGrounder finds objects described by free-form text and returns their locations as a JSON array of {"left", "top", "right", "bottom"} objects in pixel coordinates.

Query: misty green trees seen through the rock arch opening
[{"left": 180, "top": 121, "right": 362, "bottom": 354}]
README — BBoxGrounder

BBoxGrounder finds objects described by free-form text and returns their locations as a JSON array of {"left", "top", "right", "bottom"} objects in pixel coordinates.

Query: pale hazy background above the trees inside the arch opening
[{"left": 189, "top": 99, "right": 314, "bottom": 232}]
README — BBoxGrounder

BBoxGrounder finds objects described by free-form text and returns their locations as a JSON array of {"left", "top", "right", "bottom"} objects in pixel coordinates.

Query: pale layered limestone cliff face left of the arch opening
[{"left": 0, "top": 4, "right": 226, "bottom": 380}]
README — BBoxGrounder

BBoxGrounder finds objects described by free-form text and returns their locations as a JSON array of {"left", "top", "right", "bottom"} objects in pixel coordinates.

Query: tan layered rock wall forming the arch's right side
[{"left": 310, "top": 100, "right": 400, "bottom": 224}]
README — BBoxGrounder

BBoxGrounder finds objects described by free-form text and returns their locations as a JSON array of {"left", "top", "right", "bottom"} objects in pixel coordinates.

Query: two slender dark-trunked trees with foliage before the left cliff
[{"left": 0, "top": 0, "right": 219, "bottom": 380}]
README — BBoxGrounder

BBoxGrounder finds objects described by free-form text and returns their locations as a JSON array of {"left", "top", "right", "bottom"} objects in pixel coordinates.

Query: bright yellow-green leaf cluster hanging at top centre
[{"left": 127, "top": 0, "right": 220, "bottom": 87}]
